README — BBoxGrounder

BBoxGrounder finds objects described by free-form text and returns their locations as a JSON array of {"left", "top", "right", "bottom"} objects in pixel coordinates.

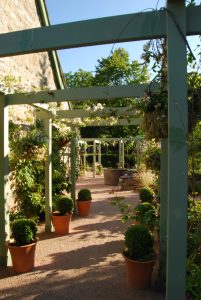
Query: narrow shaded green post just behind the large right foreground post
[{"left": 158, "top": 139, "right": 168, "bottom": 288}]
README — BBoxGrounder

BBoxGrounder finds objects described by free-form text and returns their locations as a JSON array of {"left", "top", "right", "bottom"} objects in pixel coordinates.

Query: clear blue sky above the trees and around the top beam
[{"left": 46, "top": 0, "right": 200, "bottom": 73}]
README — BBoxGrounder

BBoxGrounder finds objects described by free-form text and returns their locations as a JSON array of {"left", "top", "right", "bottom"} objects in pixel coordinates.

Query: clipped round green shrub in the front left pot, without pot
[{"left": 11, "top": 219, "right": 37, "bottom": 246}]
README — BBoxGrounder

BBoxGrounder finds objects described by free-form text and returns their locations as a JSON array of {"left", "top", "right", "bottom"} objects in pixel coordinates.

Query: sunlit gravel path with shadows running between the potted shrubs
[{"left": 0, "top": 177, "right": 165, "bottom": 300}]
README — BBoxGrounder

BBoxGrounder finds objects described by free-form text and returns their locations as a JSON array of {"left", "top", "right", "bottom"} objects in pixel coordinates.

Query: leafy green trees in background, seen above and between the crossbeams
[{"left": 65, "top": 48, "right": 149, "bottom": 137}]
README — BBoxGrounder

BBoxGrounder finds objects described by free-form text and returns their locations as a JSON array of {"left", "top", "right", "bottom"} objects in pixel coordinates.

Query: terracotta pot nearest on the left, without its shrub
[{"left": 8, "top": 243, "right": 36, "bottom": 273}]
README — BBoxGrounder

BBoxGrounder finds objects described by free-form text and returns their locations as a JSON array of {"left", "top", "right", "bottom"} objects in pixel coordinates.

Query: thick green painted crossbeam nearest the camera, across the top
[{"left": 0, "top": 6, "right": 201, "bottom": 57}]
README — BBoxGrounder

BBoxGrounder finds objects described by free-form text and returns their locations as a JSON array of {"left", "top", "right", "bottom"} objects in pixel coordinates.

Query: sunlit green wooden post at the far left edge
[{"left": 0, "top": 94, "right": 10, "bottom": 267}]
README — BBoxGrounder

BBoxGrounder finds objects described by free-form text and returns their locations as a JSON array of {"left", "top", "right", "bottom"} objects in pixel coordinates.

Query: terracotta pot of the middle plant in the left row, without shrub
[{"left": 52, "top": 214, "right": 72, "bottom": 235}]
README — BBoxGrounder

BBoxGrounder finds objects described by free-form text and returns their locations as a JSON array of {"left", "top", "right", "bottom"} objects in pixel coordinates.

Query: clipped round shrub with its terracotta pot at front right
[{"left": 123, "top": 225, "right": 155, "bottom": 289}]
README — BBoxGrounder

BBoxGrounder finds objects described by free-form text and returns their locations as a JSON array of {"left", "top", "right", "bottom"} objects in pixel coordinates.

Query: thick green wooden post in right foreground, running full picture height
[{"left": 166, "top": 0, "right": 188, "bottom": 300}]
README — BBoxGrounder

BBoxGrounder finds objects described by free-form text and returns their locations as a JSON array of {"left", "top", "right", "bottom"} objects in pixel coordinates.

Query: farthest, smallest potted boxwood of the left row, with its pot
[{"left": 77, "top": 189, "right": 92, "bottom": 217}]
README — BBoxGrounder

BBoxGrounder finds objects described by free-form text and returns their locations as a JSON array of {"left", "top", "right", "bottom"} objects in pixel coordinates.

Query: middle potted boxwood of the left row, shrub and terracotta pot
[{"left": 52, "top": 195, "right": 74, "bottom": 235}]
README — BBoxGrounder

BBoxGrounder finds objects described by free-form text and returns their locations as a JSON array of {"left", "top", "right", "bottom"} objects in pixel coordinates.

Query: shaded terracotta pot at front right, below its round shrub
[{"left": 124, "top": 256, "right": 155, "bottom": 290}]
